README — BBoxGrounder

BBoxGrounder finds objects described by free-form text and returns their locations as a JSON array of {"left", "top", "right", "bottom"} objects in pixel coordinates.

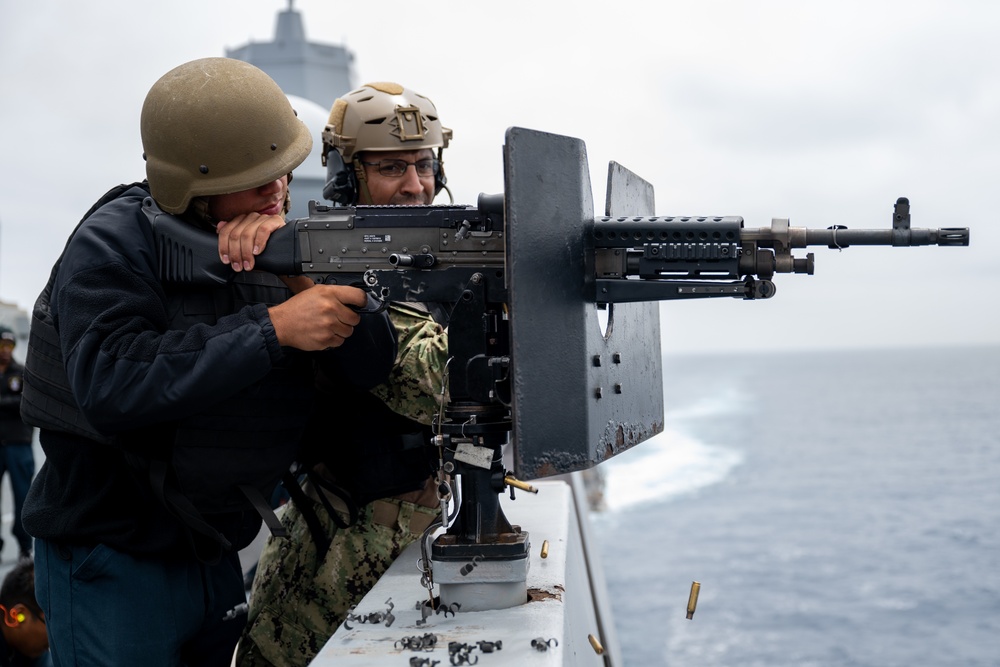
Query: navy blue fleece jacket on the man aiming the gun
[{"left": 23, "top": 187, "right": 396, "bottom": 557}]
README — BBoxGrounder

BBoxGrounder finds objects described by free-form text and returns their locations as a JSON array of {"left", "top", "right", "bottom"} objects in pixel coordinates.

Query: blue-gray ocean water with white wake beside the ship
[{"left": 591, "top": 347, "right": 1000, "bottom": 667}]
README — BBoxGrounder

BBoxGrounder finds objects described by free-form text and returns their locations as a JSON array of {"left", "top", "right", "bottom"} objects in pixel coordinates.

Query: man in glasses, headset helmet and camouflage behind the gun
[{"left": 237, "top": 83, "right": 452, "bottom": 667}]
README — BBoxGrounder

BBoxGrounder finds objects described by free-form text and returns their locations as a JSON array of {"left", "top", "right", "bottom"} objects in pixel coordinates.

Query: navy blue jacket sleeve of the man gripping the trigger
[{"left": 52, "top": 191, "right": 283, "bottom": 433}]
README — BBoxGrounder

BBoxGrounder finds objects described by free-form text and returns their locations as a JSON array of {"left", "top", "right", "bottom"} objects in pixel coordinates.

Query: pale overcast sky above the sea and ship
[{"left": 0, "top": 0, "right": 1000, "bottom": 351}]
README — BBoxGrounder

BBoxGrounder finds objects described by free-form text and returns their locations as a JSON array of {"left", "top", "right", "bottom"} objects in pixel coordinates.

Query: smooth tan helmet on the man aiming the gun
[{"left": 140, "top": 58, "right": 312, "bottom": 213}]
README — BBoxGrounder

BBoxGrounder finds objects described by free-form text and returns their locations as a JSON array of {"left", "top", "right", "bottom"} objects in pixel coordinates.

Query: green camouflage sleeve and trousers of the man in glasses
[{"left": 236, "top": 304, "right": 448, "bottom": 667}]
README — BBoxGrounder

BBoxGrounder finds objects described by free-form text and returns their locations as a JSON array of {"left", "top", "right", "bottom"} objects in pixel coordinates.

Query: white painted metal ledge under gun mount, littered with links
[{"left": 311, "top": 476, "right": 620, "bottom": 667}]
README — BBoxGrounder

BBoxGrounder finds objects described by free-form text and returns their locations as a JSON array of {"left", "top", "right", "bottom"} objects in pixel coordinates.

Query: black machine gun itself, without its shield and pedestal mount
[{"left": 150, "top": 187, "right": 969, "bottom": 304}]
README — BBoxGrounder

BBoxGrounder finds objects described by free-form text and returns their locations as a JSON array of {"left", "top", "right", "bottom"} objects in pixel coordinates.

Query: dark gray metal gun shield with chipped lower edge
[{"left": 504, "top": 127, "right": 663, "bottom": 479}]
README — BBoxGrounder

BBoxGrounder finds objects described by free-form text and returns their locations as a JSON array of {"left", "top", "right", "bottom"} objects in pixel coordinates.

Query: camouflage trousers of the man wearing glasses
[{"left": 236, "top": 488, "right": 438, "bottom": 667}]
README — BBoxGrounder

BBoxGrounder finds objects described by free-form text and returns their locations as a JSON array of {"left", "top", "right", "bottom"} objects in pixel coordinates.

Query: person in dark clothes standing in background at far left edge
[{"left": 0, "top": 327, "right": 35, "bottom": 558}]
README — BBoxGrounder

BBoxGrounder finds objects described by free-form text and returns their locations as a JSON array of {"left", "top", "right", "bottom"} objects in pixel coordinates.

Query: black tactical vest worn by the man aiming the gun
[{"left": 22, "top": 184, "right": 300, "bottom": 562}]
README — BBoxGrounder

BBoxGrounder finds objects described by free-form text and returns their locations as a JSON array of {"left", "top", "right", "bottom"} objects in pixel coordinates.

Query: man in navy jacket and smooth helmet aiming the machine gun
[{"left": 21, "top": 58, "right": 396, "bottom": 667}]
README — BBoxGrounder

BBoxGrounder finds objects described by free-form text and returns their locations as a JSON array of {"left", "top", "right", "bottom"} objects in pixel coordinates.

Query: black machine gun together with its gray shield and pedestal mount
[{"left": 149, "top": 128, "right": 969, "bottom": 610}]
